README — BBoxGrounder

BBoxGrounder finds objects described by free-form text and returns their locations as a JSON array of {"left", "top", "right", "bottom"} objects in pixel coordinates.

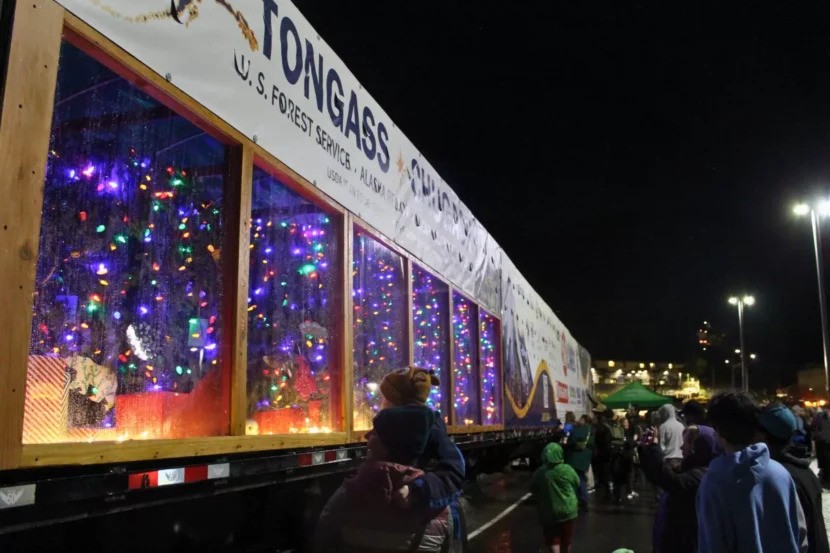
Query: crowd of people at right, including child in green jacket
[{"left": 531, "top": 392, "right": 830, "bottom": 553}]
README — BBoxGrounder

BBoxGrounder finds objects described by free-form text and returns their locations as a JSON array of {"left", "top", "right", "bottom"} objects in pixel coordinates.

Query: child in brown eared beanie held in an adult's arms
[{"left": 380, "top": 366, "right": 466, "bottom": 548}]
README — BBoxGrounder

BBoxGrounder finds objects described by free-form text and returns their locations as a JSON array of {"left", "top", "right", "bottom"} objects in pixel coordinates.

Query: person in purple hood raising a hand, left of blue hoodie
[{"left": 640, "top": 426, "right": 719, "bottom": 553}]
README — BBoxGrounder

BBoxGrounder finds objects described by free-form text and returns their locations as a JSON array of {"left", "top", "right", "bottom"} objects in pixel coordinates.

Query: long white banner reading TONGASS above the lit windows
[{"left": 58, "top": 0, "right": 500, "bottom": 313}]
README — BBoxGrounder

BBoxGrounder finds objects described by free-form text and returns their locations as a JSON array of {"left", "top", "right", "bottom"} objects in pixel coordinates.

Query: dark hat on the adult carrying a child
[{"left": 372, "top": 405, "right": 435, "bottom": 460}]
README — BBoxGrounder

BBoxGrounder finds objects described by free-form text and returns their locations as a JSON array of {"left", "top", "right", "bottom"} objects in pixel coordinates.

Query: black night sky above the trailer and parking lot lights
[{"left": 295, "top": 0, "right": 830, "bottom": 385}]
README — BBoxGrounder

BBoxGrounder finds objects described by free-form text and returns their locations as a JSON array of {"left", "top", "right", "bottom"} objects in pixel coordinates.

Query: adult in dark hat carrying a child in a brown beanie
[{"left": 314, "top": 405, "right": 450, "bottom": 553}]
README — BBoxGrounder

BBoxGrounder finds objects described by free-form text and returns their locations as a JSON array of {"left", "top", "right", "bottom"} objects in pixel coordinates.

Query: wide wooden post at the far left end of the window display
[{"left": 0, "top": 0, "right": 63, "bottom": 469}]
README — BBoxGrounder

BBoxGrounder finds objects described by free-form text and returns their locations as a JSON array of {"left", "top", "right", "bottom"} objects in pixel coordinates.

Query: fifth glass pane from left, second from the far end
[{"left": 452, "top": 292, "right": 481, "bottom": 425}]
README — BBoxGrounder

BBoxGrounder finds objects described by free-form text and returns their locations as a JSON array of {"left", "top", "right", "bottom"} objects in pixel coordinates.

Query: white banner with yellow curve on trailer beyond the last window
[{"left": 501, "top": 252, "right": 589, "bottom": 420}]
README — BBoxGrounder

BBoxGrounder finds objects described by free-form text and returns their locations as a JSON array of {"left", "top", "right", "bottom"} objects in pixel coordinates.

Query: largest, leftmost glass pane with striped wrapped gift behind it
[{"left": 23, "top": 43, "right": 229, "bottom": 443}]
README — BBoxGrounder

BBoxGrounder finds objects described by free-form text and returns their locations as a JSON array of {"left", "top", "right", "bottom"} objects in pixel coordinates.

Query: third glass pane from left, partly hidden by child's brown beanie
[{"left": 352, "top": 228, "right": 409, "bottom": 430}]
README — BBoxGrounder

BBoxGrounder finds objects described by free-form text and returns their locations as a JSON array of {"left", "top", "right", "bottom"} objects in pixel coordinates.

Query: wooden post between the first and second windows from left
[{"left": 223, "top": 145, "right": 254, "bottom": 436}]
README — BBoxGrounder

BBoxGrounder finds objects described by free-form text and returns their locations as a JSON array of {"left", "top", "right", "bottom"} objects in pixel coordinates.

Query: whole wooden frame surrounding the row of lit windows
[{"left": 0, "top": 0, "right": 504, "bottom": 470}]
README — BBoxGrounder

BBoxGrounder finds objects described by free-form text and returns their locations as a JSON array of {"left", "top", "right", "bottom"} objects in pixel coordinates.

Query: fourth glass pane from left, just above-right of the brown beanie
[{"left": 412, "top": 265, "right": 450, "bottom": 415}]
